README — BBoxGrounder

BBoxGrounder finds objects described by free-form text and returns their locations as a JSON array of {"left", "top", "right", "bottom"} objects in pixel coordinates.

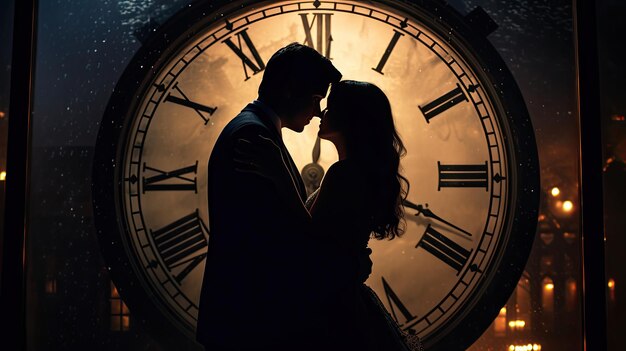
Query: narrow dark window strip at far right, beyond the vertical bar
[{"left": 597, "top": 0, "right": 626, "bottom": 351}]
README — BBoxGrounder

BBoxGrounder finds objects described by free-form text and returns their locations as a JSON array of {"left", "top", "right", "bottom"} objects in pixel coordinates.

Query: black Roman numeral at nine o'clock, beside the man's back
[{"left": 143, "top": 161, "right": 198, "bottom": 194}]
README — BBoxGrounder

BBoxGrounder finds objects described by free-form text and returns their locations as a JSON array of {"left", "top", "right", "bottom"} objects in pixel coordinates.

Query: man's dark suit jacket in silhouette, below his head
[{"left": 197, "top": 104, "right": 327, "bottom": 350}]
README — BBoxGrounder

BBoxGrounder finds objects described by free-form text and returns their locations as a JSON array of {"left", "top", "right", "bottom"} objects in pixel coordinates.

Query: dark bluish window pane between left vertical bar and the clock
[{"left": 25, "top": 0, "right": 187, "bottom": 350}]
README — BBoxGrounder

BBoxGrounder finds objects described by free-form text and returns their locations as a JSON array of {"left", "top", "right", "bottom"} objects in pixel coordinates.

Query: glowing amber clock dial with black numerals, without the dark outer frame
[{"left": 94, "top": 1, "right": 532, "bottom": 350}]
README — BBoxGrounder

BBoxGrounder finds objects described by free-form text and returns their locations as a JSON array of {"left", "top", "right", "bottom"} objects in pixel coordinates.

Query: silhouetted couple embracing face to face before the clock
[{"left": 197, "top": 43, "right": 420, "bottom": 351}]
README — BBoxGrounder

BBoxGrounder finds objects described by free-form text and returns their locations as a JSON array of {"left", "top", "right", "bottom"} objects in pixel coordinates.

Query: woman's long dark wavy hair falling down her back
[{"left": 328, "top": 80, "right": 409, "bottom": 240}]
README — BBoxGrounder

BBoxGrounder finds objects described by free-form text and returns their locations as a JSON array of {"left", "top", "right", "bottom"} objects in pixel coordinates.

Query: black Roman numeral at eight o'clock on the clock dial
[{"left": 150, "top": 209, "right": 209, "bottom": 284}]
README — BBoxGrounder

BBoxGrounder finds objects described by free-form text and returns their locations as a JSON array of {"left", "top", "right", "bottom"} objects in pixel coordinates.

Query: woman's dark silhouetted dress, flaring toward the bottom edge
[{"left": 306, "top": 160, "right": 422, "bottom": 351}]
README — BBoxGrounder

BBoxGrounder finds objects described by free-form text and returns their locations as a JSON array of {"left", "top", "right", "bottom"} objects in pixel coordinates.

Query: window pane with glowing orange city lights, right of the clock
[{"left": 442, "top": 0, "right": 582, "bottom": 350}]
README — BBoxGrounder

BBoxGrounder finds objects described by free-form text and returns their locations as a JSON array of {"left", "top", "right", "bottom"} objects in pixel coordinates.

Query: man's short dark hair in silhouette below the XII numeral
[{"left": 259, "top": 43, "right": 341, "bottom": 100}]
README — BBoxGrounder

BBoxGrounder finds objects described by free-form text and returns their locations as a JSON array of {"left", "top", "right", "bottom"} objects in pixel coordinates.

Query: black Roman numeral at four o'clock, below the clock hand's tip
[{"left": 415, "top": 224, "right": 472, "bottom": 275}]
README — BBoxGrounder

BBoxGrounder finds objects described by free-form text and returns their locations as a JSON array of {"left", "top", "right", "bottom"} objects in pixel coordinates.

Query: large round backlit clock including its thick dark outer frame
[{"left": 93, "top": 0, "right": 539, "bottom": 350}]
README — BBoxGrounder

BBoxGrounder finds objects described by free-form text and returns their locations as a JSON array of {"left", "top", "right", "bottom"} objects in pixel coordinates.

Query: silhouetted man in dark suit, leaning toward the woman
[{"left": 197, "top": 43, "right": 341, "bottom": 350}]
